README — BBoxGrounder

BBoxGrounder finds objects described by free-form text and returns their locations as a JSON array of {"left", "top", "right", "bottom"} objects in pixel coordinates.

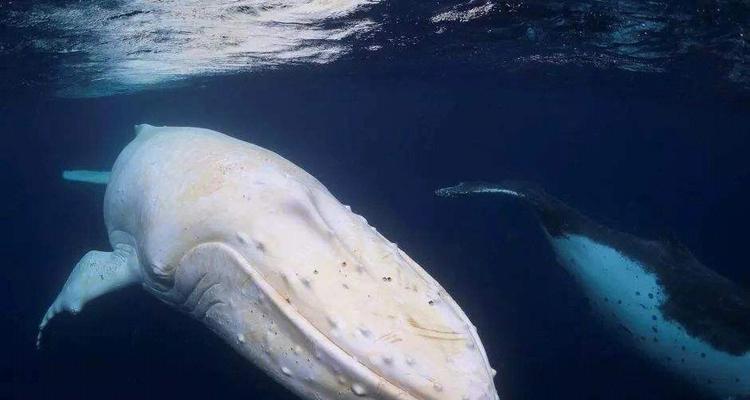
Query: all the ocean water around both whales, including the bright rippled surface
[{"left": 0, "top": 0, "right": 750, "bottom": 400}]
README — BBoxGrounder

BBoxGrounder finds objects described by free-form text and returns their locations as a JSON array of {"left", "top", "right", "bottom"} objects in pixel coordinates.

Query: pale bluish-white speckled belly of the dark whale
[{"left": 550, "top": 235, "right": 750, "bottom": 397}]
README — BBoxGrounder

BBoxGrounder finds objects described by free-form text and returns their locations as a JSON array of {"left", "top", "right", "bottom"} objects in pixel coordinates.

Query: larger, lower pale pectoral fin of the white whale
[{"left": 36, "top": 245, "right": 140, "bottom": 348}]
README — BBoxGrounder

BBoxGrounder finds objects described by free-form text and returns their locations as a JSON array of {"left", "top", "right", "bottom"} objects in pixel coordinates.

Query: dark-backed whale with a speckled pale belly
[{"left": 437, "top": 182, "right": 750, "bottom": 399}]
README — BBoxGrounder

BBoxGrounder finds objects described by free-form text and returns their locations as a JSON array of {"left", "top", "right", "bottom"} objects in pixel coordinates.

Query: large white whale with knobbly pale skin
[{"left": 39, "top": 125, "right": 498, "bottom": 400}]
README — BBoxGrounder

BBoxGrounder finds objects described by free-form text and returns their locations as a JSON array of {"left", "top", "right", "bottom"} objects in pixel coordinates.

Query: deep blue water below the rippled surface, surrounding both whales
[{"left": 0, "top": 3, "right": 750, "bottom": 399}]
